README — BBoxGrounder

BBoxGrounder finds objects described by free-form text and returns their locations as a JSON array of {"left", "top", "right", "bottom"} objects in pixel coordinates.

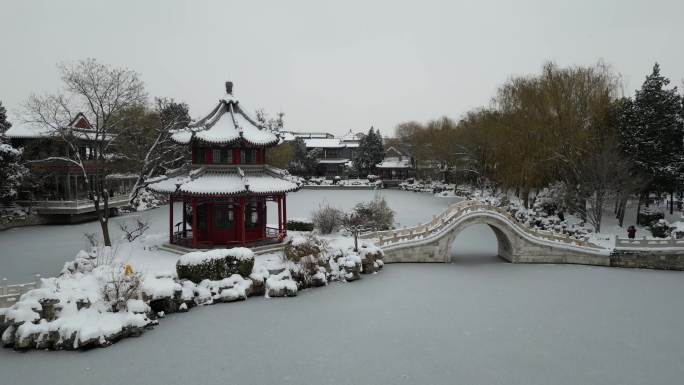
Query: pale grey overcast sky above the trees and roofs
[{"left": 0, "top": 0, "right": 684, "bottom": 134}]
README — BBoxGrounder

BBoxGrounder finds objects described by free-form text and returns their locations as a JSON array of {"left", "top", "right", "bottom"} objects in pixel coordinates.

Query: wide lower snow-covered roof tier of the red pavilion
[{"left": 148, "top": 167, "right": 300, "bottom": 195}]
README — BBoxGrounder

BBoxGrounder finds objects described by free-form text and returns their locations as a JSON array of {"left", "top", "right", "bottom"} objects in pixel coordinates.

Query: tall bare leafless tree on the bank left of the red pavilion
[{"left": 25, "top": 59, "right": 147, "bottom": 246}]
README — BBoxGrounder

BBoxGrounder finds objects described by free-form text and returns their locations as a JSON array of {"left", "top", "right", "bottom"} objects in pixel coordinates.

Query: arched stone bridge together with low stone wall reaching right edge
[{"left": 360, "top": 201, "right": 684, "bottom": 270}]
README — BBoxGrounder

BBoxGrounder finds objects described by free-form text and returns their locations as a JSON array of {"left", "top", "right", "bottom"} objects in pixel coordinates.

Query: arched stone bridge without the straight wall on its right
[{"left": 361, "top": 201, "right": 612, "bottom": 266}]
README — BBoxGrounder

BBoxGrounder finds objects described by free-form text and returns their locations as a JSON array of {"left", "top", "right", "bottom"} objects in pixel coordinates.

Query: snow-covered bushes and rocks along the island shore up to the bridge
[{"left": 0, "top": 236, "right": 383, "bottom": 350}]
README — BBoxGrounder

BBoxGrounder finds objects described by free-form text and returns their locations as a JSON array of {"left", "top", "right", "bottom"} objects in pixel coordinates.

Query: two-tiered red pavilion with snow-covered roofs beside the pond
[{"left": 149, "top": 82, "right": 299, "bottom": 248}]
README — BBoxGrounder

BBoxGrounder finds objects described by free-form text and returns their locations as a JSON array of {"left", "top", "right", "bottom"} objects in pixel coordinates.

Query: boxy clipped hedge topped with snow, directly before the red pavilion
[{"left": 176, "top": 247, "right": 254, "bottom": 283}]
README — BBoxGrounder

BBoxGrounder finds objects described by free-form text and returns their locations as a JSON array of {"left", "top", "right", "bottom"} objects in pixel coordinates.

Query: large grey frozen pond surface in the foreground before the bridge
[{"left": 0, "top": 189, "right": 684, "bottom": 385}]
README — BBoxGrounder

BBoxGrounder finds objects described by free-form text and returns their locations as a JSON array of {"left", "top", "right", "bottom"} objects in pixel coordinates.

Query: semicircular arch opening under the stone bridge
[{"left": 449, "top": 223, "right": 512, "bottom": 264}]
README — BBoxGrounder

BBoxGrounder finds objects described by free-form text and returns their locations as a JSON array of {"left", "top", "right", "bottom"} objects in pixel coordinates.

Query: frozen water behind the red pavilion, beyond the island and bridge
[{"left": 0, "top": 190, "right": 455, "bottom": 282}]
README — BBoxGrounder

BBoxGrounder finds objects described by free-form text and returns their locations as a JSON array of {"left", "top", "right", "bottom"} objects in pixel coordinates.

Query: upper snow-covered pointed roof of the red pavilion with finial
[{"left": 172, "top": 82, "right": 279, "bottom": 146}]
